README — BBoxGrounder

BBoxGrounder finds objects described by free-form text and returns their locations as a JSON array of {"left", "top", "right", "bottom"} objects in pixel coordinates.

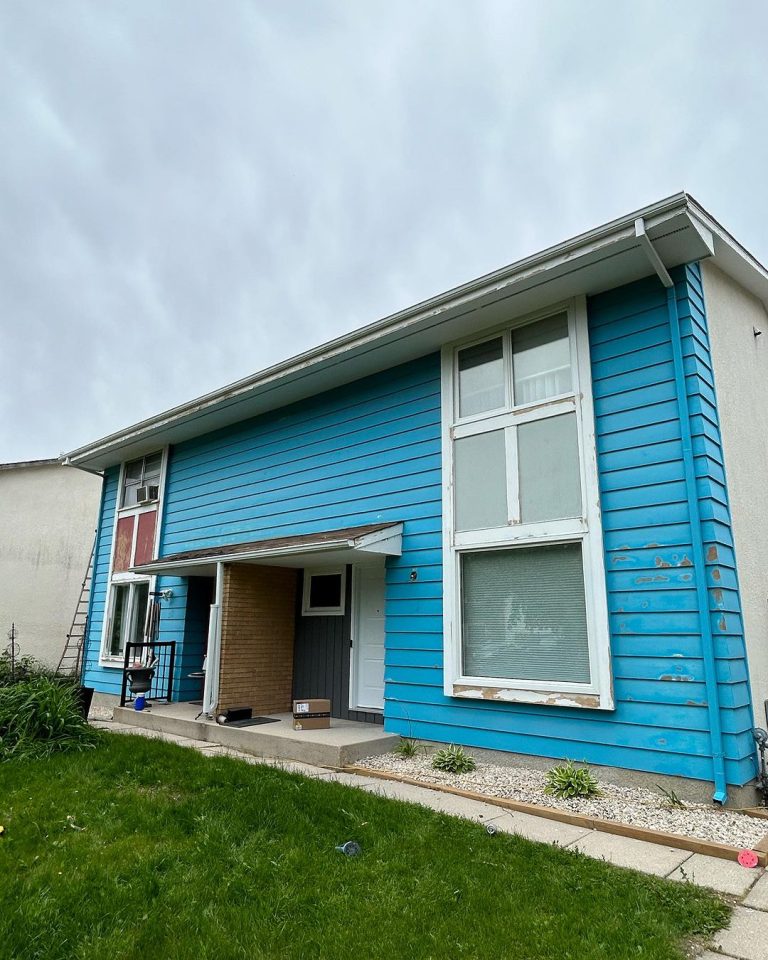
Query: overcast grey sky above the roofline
[{"left": 0, "top": 0, "right": 768, "bottom": 461}]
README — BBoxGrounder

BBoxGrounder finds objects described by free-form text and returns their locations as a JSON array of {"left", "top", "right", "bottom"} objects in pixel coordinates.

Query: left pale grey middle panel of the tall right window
[{"left": 453, "top": 430, "right": 508, "bottom": 530}]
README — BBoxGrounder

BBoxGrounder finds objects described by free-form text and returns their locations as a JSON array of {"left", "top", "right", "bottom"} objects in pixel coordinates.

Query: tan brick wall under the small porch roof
[{"left": 217, "top": 564, "right": 297, "bottom": 714}]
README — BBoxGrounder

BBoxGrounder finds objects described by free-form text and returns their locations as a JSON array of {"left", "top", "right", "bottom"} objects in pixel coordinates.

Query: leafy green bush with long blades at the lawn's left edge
[{"left": 0, "top": 676, "right": 99, "bottom": 760}]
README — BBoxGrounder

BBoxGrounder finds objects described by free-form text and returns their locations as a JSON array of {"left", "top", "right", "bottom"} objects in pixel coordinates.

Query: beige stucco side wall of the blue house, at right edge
[{"left": 702, "top": 261, "right": 768, "bottom": 727}]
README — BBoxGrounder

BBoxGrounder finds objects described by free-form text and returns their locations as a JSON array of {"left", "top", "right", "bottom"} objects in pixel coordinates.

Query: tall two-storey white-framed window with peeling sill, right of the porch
[{"left": 442, "top": 298, "right": 613, "bottom": 709}]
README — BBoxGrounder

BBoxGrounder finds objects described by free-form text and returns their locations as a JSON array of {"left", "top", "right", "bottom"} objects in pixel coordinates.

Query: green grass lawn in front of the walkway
[{"left": 0, "top": 735, "right": 728, "bottom": 960}]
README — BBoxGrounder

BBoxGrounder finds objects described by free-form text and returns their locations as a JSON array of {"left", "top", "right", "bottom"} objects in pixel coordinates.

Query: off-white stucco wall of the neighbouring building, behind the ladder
[{"left": 0, "top": 462, "right": 101, "bottom": 665}]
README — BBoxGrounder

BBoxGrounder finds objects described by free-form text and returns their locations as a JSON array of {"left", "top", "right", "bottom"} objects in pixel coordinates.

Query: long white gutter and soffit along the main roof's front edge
[{"left": 62, "top": 193, "right": 759, "bottom": 469}]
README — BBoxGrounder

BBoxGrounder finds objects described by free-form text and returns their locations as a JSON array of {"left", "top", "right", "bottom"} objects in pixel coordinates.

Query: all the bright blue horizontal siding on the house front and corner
[{"left": 82, "top": 264, "right": 756, "bottom": 784}]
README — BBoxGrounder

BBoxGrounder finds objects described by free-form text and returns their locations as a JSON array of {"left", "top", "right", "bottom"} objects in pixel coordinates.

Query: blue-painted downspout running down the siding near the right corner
[{"left": 667, "top": 286, "right": 728, "bottom": 803}]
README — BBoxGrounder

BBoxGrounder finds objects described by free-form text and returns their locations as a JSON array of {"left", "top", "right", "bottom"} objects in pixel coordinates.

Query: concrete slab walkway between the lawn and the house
[{"left": 91, "top": 720, "right": 768, "bottom": 960}]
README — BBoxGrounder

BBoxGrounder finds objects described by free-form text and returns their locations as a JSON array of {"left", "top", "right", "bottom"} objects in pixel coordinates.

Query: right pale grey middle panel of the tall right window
[{"left": 517, "top": 413, "right": 581, "bottom": 523}]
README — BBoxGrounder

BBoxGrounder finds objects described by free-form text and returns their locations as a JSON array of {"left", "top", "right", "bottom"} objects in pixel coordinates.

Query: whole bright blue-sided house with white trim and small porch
[{"left": 66, "top": 193, "right": 768, "bottom": 801}]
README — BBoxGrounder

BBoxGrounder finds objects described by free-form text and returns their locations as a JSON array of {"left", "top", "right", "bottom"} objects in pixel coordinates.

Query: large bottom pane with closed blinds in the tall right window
[{"left": 461, "top": 543, "right": 590, "bottom": 683}]
